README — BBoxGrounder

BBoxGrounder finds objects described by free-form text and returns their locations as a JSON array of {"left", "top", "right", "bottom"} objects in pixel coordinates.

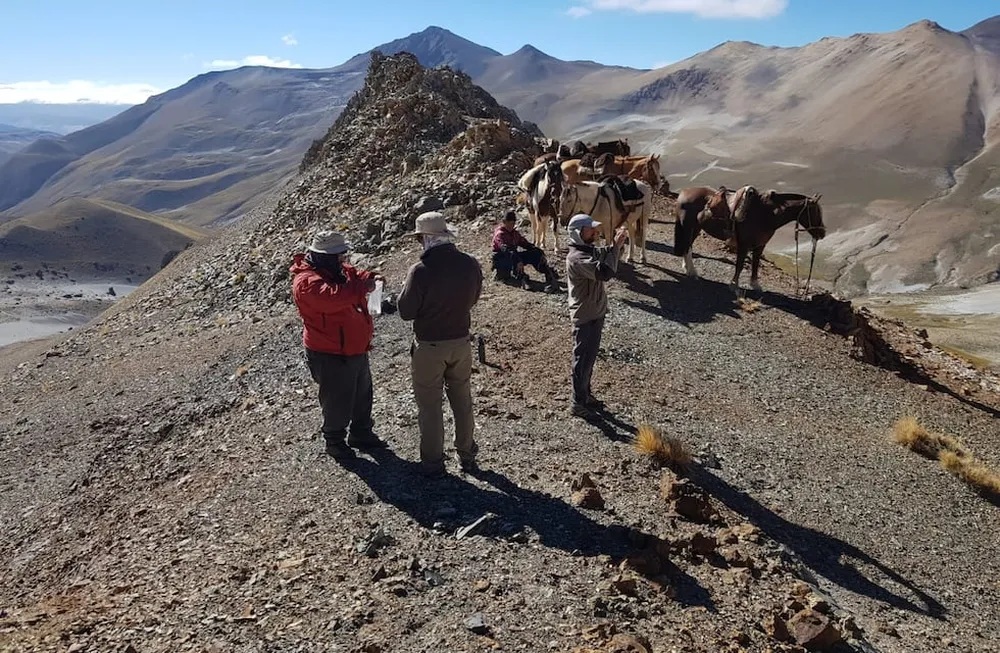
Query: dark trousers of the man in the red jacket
[{"left": 306, "top": 349, "right": 374, "bottom": 441}]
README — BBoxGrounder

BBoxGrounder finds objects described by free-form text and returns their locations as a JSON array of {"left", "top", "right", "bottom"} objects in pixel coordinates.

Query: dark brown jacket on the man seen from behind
[{"left": 397, "top": 243, "right": 483, "bottom": 342}]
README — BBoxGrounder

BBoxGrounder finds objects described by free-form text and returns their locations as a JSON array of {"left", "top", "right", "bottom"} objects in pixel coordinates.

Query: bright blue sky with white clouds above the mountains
[{"left": 0, "top": 0, "right": 1000, "bottom": 103}]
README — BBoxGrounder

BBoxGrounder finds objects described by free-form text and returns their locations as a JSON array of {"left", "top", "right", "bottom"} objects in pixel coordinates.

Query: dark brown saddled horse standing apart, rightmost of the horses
[{"left": 674, "top": 186, "right": 826, "bottom": 291}]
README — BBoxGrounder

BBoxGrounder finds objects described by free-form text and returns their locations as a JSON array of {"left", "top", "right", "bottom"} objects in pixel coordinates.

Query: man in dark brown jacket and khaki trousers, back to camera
[{"left": 396, "top": 211, "right": 483, "bottom": 476}]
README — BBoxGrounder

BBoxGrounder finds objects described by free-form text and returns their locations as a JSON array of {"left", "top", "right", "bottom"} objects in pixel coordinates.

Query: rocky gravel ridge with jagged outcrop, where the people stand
[{"left": 0, "top": 53, "right": 1000, "bottom": 653}]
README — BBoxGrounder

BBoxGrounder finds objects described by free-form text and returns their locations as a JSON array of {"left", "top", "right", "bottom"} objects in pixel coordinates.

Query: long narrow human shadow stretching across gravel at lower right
[{"left": 686, "top": 465, "right": 946, "bottom": 619}]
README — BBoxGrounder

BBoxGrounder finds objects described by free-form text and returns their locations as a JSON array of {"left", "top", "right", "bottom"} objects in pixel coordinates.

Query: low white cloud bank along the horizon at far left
[{"left": 0, "top": 79, "right": 163, "bottom": 104}]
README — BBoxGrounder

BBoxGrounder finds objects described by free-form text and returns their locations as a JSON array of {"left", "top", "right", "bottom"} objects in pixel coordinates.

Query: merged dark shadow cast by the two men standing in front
[{"left": 341, "top": 450, "right": 716, "bottom": 612}]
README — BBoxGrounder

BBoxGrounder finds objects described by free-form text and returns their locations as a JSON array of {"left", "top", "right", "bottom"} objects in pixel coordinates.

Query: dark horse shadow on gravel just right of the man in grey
[{"left": 617, "top": 266, "right": 742, "bottom": 327}]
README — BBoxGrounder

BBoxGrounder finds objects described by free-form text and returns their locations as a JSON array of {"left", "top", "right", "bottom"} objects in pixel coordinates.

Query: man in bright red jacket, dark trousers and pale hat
[{"left": 289, "top": 231, "right": 388, "bottom": 458}]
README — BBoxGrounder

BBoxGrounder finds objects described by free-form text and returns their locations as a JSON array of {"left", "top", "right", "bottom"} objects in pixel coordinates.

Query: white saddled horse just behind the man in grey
[{"left": 559, "top": 181, "right": 653, "bottom": 263}]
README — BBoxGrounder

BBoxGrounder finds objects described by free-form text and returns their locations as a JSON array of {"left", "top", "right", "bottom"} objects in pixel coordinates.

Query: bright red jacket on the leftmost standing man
[{"left": 288, "top": 254, "right": 375, "bottom": 356}]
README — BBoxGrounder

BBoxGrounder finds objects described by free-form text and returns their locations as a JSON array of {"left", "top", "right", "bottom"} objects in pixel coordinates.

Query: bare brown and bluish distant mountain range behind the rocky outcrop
[{"left": 0, "top": 17, "right": 1000, "bottom": 292}]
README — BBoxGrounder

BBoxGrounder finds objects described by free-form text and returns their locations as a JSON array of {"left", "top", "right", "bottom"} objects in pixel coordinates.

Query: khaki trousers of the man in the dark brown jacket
[{"left": 410, "top": 338, "right": 478, "bottom": 469}]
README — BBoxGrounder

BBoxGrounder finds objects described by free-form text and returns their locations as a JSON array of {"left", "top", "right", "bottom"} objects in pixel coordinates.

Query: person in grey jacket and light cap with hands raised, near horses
[{"left": 566, "top": 213, "right": 628, "bottom": 420}]
